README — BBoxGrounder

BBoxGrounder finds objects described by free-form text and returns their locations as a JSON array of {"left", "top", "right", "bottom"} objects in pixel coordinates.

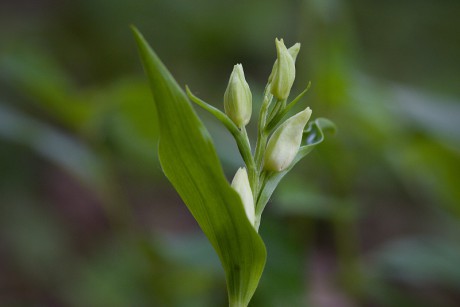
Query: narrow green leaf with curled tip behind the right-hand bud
[{"left": 256, "top": 118, "right": 336, "bottom": 216}]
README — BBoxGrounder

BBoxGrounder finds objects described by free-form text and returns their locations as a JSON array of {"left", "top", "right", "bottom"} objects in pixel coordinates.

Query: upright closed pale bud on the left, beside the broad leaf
[{"left": 224, "top": 64, "right": 252, "bottom": 128}]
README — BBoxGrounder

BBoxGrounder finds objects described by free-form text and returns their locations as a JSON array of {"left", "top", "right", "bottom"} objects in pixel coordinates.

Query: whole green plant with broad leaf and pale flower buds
[{"left": 133, "top": 27, "right": 334, "bottom": 307}]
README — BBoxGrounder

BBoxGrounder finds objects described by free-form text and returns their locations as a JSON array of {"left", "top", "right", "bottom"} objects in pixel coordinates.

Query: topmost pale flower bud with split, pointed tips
[{"left": 270, "top": 39, "right": 300, "bottom": 100}]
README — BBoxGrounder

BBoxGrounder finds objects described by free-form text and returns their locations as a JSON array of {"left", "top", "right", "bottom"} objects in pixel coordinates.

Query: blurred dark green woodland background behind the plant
[{"left": 0, "top": 0, "right": 460, "bottom": 307}]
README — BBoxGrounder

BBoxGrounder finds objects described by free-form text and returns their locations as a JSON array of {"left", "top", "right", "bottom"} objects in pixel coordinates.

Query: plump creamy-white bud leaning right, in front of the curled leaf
[{"left": 264, "top": 108, "right": 311, "bottom": 172}]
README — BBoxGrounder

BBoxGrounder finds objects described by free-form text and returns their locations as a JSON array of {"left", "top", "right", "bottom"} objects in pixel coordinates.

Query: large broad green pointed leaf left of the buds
[{"left": 133, "top": 28, "right": 266, "bottom": 306}]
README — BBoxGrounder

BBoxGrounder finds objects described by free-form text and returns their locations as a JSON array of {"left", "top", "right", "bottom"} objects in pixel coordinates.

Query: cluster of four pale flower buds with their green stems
[{"left": 194, "top": 39, "right": 311, "bottom": 229}]
